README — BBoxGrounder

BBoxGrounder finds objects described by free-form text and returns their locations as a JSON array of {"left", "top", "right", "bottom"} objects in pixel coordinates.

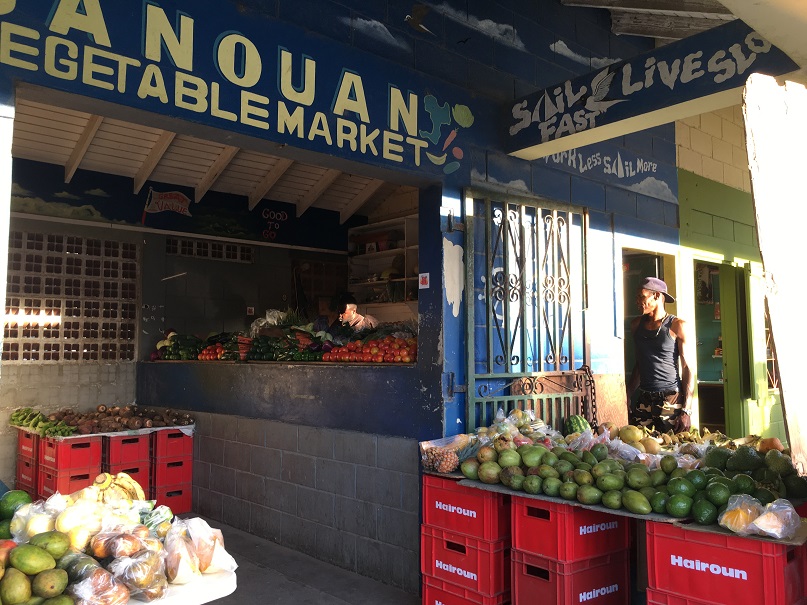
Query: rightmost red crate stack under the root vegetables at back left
[{"left": 149, "top": 429, "right": 193, "bottom": 514}]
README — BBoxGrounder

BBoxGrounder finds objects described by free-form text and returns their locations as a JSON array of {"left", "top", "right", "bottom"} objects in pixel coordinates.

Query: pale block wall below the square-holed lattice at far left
[{"left": 0, "top": 362, "right": 135, "bottom": 486}]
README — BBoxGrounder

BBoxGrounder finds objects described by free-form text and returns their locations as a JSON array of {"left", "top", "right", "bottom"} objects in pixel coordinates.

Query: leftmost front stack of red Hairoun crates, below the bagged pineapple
[{"left": 420, "top": 474, "right": 510, "bottom": 605}]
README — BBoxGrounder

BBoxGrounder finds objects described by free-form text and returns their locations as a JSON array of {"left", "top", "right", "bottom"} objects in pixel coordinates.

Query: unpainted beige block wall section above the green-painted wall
[{"left": 675, "top": 105, "right": 751, "bottom": 192}]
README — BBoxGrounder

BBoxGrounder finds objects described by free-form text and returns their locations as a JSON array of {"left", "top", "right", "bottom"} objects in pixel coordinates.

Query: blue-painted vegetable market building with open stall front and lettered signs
[{"left": 0, "top": 0, "right": 798, "bottom": 593}]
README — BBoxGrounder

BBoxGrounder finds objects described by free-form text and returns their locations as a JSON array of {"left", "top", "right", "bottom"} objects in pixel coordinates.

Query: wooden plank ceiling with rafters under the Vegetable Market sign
[{"left": 12, "top": 97, "right": 413, "bottom": 223}]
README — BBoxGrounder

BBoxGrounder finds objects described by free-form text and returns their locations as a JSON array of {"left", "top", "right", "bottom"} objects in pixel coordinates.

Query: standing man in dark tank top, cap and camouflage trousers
[{"left": 626, "top": 277, "right": 693, "bottom": 433}]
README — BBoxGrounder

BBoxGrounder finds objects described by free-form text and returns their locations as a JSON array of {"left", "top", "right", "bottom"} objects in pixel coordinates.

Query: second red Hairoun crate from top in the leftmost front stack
[{"left": 420, "top": 525, "right": 510, "bottom": 596}]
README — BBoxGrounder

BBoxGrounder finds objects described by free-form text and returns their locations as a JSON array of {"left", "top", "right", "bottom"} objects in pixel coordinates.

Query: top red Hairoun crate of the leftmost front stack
[{"left": 423, "top": 475, "right": 510, "bottom": 541}]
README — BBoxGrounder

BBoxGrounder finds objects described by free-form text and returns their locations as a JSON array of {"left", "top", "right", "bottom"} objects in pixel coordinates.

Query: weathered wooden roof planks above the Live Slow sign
[{"left": 561, "top": 0, "right": 736, "bottom": 46}]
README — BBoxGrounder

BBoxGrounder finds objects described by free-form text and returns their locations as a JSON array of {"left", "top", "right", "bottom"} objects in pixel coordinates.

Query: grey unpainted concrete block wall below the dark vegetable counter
[{"left": 192, "top": 412, "right": 420, "bottom": 594}]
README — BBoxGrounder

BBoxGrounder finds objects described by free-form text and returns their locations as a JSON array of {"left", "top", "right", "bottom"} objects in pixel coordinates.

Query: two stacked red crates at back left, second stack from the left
[{"left": 37, "top": 435, "right": 102, "bottom": 499}]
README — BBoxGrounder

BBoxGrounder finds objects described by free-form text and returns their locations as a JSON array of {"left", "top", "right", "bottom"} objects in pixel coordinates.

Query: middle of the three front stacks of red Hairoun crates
[{"left": 510, "top": 496, "right": 633, "bottom": 605}]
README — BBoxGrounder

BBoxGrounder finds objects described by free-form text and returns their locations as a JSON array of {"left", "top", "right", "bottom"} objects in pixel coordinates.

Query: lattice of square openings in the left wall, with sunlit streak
[{"left": 2, "top": 231, "right": 139, "bottom": 363}]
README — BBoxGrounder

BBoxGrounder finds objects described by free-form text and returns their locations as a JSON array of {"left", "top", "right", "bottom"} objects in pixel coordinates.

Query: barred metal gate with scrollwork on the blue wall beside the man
[{"left": 465, "top": 192, "right": 597, "bottom": 430}]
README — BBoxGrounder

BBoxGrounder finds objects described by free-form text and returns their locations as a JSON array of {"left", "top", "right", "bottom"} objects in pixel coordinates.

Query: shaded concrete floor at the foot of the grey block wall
[{"left": 208, "top": 519, "right": 421, "bottom": 605}]
